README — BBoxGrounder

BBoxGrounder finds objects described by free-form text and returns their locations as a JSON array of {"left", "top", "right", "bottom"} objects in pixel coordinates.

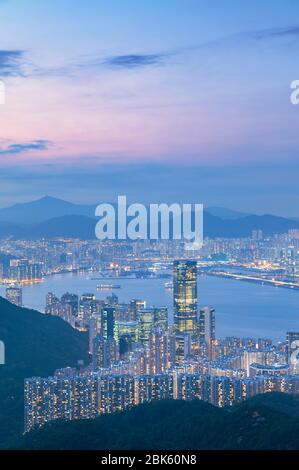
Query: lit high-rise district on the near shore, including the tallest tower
[{"left": 25, "top": 260, "right": 299, "bottom": 432}]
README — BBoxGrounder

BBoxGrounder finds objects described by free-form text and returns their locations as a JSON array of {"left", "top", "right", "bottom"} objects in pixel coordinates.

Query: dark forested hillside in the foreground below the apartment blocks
[{"left": 12, "top": 393, "right": 299, "bottom": 451}]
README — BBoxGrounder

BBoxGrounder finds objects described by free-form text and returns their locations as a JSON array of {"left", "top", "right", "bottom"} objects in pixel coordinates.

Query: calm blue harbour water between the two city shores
[{"left": 0, "top": 274, "right": 299, "bottom": 340}]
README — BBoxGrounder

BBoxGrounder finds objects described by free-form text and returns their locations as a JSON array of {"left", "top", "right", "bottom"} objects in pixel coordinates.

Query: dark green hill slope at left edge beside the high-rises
[{"left": 0, "top": 297, "right": 88, "bottom": 448}]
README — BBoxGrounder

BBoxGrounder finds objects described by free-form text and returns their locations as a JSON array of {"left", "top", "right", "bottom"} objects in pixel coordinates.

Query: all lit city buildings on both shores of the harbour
[{"left": 1, "top": 230, "right": 299, "bottom": 432}]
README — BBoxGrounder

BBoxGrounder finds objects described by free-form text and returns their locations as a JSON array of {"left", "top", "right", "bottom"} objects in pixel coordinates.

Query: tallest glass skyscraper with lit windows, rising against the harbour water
[{"left": 173, "top": 261, "right": 198, "bottom": 335}]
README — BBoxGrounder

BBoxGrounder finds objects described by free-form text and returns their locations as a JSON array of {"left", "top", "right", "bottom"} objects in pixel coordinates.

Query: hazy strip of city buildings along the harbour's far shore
[{"left": 0, "top": 229, "right": 299, "bottom": 284}]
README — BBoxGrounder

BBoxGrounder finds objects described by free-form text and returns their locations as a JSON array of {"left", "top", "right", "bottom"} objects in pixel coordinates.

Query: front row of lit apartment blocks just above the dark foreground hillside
[{"left": 25, "top": 370, "right": 299, "bottom": 432}]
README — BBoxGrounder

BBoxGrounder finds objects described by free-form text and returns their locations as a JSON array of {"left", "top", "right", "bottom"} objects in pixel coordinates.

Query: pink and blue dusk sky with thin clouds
[{"left": 0, "top": 0, "right": 299, "bottom": 217}]
